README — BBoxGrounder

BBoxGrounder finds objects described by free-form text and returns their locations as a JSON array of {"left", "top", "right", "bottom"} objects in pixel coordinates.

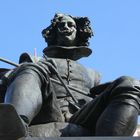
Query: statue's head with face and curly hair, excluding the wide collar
[{"left": 42, "top": 13, "right": 93, "bottom": 46}]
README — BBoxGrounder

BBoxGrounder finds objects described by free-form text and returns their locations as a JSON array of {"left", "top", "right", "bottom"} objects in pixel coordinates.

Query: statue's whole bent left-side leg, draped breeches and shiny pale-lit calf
[{"left": 0, "top": 64, "right": 62, "bottom": 140}]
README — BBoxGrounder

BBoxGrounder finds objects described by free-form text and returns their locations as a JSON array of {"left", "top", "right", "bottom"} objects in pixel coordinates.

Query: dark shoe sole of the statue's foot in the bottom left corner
[{"left": 0, "top": 104, "right": 27, "bottom": 140}]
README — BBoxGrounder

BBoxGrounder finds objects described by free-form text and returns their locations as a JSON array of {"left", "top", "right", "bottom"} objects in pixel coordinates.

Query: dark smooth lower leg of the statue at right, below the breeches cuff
[{"left": 95, "top": 98, "right": 138, "bottom": 136}]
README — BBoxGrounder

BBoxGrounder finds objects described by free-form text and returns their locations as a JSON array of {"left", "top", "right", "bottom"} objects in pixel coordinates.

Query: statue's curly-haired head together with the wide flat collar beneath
[{"left": 42, "top": 13, "right": 93, "bottom": 60}]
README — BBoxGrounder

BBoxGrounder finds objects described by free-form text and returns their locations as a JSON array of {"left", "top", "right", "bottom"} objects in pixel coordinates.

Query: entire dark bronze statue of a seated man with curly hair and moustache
[{"left": 0, "top": 13, "right": 140, "bottom": 137}]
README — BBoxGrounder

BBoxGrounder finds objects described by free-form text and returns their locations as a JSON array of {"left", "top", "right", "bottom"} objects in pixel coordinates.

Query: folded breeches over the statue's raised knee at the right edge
[{"left": 110, "top": 76, "right": 140, "bottom": 110}]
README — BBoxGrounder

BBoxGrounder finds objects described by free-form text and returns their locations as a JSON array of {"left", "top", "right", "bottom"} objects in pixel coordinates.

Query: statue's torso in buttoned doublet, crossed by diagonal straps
[{"left": 48, "top": 58, "right": 99, "bottom": 121}]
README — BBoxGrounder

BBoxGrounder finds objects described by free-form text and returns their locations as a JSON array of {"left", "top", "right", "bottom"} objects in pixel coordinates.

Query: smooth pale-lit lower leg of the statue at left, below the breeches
[{"left": 4, "top": 68, "right": 42, "bottom": 124}]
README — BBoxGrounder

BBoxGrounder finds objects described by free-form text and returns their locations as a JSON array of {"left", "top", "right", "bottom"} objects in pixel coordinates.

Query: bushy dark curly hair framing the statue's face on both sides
[{"left": 42, "top": 13, "right": 93, "bottom": 46}]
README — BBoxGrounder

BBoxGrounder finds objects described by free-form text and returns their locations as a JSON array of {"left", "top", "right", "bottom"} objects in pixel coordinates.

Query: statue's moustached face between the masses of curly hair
[{"left": 57, "top": 16, "right": 77, "bottom": 46}]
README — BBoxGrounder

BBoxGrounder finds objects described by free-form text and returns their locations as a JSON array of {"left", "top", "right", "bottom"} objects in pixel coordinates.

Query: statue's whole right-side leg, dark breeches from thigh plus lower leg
[{"left": 70, "top": 76, "right": 140, "bottom": 136}]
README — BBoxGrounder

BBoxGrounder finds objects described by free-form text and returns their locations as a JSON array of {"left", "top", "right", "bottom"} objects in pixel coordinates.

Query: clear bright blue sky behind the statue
[{"left": 0, "top": 0, "right": 140, "bottom": 123}]
